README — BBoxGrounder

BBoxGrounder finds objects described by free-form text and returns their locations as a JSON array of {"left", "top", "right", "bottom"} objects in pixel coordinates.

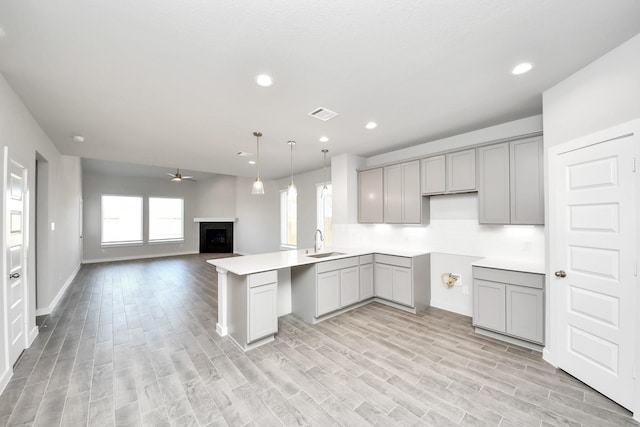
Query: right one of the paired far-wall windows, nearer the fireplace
[{"left": 149, "top": 197, "right": 184, "bottom": 242}]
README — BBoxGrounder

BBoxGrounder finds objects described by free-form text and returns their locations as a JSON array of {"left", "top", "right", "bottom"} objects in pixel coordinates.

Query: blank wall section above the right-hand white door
[{"left": 542, "top": 35, "right": 640, "bottom": 147}]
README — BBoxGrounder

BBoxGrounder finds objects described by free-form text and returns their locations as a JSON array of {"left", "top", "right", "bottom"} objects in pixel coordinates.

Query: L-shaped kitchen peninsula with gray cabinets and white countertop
[{"left": 207, "top": 249, "right": 431, "bottom": 350}]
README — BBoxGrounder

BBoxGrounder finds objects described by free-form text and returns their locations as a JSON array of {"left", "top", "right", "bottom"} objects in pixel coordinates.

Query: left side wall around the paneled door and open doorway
[{"left": 0, "top": 74, "right": 82, "bottom": 390}]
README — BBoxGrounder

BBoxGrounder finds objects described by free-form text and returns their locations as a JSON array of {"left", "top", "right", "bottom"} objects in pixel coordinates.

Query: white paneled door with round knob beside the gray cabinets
[{"left": 550, "top": 129, "right": 638, "bottom": 408}]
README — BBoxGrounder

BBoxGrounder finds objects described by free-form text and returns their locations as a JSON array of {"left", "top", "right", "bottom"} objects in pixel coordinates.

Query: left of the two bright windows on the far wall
[{"left": 102, "top": 195, "right": 142, "bottom": 245}]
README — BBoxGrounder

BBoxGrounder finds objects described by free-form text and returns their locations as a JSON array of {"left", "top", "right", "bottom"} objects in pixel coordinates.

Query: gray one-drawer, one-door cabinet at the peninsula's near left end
[{"left": 228, "top": 270, "right": 278, "bottom": 350}]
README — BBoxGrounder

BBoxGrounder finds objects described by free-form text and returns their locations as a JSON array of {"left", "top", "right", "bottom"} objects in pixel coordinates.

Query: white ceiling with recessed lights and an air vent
[{"left": 0, "top": 0, "right": 640, "bottom": 178}]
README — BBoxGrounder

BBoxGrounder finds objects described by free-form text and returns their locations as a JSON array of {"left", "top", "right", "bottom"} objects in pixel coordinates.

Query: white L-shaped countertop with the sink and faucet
[{"left": 207, "top": 248, "right": 426, "bottom": 276}]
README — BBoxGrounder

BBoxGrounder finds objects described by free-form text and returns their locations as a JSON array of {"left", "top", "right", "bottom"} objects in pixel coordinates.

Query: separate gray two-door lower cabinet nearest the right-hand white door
[{"left": 473, "top": 266, "right": 544, "bottom": 344}]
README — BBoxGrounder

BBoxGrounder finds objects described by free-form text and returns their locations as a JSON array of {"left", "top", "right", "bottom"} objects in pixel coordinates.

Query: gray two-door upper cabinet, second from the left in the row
[{"left": 384, "top": 160, "right": 422, "bottom": 224}]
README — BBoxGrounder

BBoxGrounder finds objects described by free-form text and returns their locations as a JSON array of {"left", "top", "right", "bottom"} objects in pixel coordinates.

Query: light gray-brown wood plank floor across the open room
[{"left": 0, "top": 255, "right": 636, "bottom": 427}]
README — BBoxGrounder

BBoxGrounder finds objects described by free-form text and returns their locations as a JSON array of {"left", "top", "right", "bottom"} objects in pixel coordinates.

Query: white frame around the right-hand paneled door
[{"left": 543, "top": 119, "right": 640, "bottom": 421}]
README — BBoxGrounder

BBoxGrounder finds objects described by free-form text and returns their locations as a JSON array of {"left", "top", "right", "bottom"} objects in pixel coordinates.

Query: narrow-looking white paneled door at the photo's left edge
[{"left": 4, "top": 148, "right": 27, "bottom": 365}]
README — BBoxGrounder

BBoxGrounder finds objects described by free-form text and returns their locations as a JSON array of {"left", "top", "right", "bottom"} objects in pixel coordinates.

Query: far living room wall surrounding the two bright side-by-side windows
[{"left": 83, "top": 173, "right": 200, "bottom": 262}]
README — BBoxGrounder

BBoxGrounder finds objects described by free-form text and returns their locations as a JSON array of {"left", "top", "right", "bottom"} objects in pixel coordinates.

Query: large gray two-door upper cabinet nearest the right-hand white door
[{"left": 478, "top": 138, "right": 544, "bottom": 224}]
